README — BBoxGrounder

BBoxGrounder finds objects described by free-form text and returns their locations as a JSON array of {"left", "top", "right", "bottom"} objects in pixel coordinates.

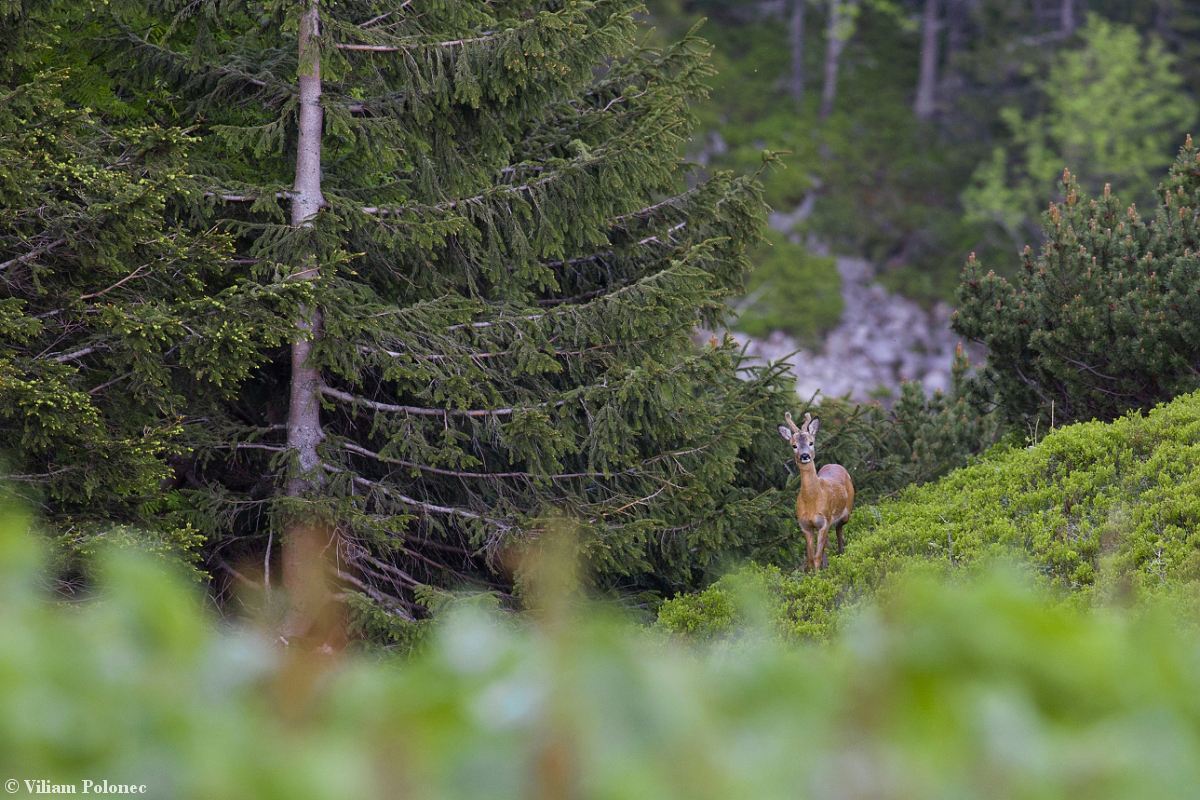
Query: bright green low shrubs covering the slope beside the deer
[{"left": 659, "top": 392, "right": 1200, "bottom": 636}]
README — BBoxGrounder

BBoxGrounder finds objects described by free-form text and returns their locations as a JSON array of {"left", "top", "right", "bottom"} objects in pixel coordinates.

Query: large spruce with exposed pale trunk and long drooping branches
[{"left": 106, "top": 0, "right": 790, "bottom": 619}]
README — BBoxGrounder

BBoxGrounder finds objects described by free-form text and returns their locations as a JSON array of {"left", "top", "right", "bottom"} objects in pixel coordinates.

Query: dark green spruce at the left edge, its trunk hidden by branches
[{"left": 0, "top": 4, "right": 297, "bottom": 572}]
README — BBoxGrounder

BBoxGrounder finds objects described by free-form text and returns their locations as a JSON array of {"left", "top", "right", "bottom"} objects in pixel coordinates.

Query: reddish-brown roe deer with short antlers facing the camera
[{"left": 779, "top": 413, "right": 854, "bottom": 572}]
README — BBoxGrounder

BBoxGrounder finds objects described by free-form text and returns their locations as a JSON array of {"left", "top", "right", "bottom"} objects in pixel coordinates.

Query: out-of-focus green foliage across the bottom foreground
[{"left": 7, "top": 484, "right": 1200, "bottom": 800}]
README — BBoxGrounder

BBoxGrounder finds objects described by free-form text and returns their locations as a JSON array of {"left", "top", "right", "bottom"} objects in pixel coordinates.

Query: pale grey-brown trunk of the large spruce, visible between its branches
[{"left": 283, "top": 0, "right": 325, "bottom": 637}]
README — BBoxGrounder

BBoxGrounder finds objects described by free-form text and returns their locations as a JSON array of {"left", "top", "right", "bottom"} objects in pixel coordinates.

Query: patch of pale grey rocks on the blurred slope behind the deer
[{"left": 715, "top": 257, "right": 984, "bottom": 401}]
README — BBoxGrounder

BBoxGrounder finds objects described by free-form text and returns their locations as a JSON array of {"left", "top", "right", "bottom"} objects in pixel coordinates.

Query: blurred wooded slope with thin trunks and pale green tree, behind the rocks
[{"left": 650, "top": 0, "right": 1200, "bottom": 333}]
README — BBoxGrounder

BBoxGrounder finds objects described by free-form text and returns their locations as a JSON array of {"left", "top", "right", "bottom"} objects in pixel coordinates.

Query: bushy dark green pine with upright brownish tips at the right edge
[{"left": 955, "top": 138, "right": 1200, "bottom": 432}]
